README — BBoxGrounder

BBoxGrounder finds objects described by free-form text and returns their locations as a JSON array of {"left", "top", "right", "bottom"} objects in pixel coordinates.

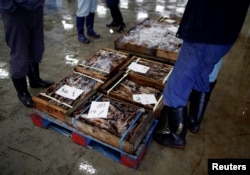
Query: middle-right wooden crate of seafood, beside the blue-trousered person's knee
[{"left": 99, "top": 72, "right": 163, "bottom": 118}]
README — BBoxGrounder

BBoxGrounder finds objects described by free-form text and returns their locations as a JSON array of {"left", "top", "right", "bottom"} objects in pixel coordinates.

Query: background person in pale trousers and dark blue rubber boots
[{"left": 76, "top": 0, "right": 101, "bottom": 44}]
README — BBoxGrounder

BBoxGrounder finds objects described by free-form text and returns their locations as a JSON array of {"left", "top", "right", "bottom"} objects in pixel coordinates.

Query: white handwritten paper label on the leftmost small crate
[{"left": 56, "top": 85, "right": 83, "bottom": 100}]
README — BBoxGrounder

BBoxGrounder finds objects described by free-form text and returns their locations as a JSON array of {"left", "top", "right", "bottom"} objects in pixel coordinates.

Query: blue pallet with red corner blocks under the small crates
[{"left": 31, "top": 110, "right": 158, "bottom": 168}]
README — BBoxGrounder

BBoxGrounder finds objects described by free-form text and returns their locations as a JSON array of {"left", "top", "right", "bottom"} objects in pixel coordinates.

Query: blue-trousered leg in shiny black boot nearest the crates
[{"left": 154, "top": 42, "right": 200, "bottom": 148}]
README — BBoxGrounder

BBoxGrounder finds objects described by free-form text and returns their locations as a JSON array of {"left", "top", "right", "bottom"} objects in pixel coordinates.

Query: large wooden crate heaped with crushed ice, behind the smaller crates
[{"left": 114, "top": 17, "right": 182, "bottom": 63}]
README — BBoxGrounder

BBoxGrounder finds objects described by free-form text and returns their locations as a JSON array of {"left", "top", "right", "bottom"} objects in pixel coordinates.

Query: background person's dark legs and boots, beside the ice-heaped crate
[{"left": 106, "top": 0, "right": 126, "bottom": 33}]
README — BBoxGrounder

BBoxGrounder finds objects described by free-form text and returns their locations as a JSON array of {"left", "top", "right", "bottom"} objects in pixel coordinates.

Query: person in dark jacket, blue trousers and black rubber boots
[{"left": 154, "top": 0, "right": 250, "bottom": 149}]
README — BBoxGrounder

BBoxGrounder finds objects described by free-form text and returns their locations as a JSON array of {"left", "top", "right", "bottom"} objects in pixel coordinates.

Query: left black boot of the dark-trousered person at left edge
[{"left": 12, "top": 77, "right": 34, "bottom": 108}]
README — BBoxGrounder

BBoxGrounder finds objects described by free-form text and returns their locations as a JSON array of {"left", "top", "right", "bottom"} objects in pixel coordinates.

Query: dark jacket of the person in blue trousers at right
[{"left": 177, "top": 0, "right": 250, "bottom": 44}]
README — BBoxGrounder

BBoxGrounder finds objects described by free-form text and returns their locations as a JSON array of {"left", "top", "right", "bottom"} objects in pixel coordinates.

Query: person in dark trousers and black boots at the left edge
[{"left": 0, "top": 0, "right": 54, "bottom": 107}]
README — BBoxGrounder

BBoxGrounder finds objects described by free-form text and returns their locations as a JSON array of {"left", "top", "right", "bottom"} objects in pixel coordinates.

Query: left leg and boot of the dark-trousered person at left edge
[{"left": 2, "top": 8, "right": 34, "bottom": 107}]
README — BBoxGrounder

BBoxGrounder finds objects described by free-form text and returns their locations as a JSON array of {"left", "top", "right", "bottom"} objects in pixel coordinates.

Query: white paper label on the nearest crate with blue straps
[{"left": 87, "top": 101, "right": 110, "bottom": 118}]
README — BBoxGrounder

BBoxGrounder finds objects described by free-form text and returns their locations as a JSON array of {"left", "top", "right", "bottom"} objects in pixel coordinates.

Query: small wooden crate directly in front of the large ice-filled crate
[{"left": 127, "top": 57, "right": 173, "bottom": 90}]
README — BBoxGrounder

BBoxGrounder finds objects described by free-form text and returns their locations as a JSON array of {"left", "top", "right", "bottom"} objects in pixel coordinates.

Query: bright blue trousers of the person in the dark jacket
[{"left": 163, "top": 41, "right": 233, "bottom": 108}]
